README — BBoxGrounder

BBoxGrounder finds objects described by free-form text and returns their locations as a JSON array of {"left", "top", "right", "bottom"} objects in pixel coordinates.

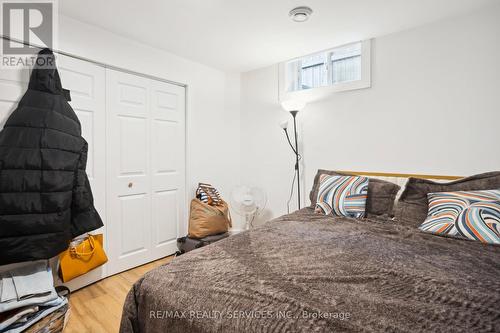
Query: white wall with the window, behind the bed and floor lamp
[{"left": 241, "top": 5, "right": 500, "bottom": 220}]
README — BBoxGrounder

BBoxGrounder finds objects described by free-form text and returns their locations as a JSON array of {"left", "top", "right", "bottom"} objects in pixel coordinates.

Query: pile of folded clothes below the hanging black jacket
[{"left": 0, "top": 260, "right": 68, "bottom": 333}]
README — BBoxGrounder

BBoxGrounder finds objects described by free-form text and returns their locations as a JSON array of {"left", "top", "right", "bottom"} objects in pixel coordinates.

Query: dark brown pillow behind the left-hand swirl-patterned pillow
[{"left": 309, "top": 169, "right": 400, "bottom": 218}]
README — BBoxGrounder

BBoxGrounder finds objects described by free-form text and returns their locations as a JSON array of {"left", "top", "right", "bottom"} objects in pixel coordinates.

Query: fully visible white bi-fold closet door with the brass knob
[{"left": 106, "top": 70, "right": 185, "bottom": 274}]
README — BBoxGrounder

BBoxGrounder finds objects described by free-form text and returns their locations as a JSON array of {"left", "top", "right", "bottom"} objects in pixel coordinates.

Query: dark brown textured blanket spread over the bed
[{"left": 120, "top": 208, "right": 500, "bottom": 332}]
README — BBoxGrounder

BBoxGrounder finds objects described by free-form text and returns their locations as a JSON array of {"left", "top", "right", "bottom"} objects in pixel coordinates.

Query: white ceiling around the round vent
[{"left": 59, "top": 0, "right": 498, "bottom": 72}]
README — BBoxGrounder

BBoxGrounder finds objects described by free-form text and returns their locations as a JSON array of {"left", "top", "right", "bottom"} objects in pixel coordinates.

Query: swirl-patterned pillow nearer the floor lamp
[{"left": 316, "top": 175, "right": 368, "bottom": 218}]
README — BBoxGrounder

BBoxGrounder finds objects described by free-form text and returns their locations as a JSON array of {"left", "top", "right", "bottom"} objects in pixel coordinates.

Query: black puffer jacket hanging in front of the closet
[{"left": 0, "top": 49, "right": 102, "bottom": 265}]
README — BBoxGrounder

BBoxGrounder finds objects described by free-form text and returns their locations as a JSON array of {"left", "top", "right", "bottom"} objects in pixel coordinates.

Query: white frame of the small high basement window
[{"left": 279, "top": 39, "right": 371, "bottom": 102}]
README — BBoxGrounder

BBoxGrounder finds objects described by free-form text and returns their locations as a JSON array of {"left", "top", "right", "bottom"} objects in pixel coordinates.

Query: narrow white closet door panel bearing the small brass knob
[{"left": 106, "top": 70, "right": 151, "bottom": 274}]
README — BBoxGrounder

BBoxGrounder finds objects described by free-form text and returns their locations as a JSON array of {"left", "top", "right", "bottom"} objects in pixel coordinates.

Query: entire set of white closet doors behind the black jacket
[{"left": 0, "top": 55, "right": 187, "bottom": 289}]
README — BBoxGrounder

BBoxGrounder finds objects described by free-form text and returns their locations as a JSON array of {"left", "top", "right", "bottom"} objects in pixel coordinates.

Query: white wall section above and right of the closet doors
[{"left": 58, "top": 16, "right": 240, "bottom": 234}]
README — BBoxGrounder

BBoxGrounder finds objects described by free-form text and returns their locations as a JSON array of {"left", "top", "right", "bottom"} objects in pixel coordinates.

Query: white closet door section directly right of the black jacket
[{"left": 57, "top": 55, "right": 107, "bottom": 290}]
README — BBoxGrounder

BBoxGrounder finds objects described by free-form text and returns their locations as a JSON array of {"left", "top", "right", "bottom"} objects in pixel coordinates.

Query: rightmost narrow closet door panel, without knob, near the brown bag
[{"left": 151, "top": 81, "right": 185, "bottom": 257}]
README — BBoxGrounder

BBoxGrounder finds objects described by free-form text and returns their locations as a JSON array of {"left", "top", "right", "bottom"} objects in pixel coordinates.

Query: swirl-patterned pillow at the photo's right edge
[{"left": 419, "top": 190, "right": 500, "bottom": 244}]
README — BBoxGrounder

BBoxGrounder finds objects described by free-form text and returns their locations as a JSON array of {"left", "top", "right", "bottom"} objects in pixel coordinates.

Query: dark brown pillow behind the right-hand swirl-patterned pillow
[{"left": 394, "top": 171, "right": 500, "bottom": 227}]
